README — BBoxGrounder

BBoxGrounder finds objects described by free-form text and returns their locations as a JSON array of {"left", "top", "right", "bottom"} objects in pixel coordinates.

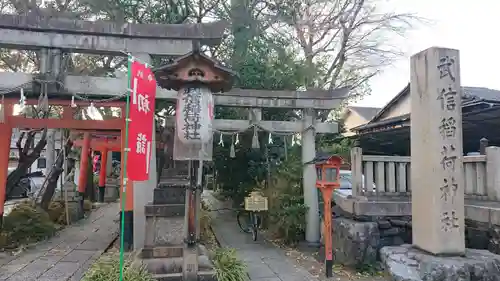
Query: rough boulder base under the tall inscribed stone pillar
[{"left": 380, "top": 245, "right": 500, "bottom": 281}]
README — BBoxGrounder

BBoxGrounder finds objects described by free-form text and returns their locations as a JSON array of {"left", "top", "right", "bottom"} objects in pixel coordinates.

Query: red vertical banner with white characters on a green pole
[{"left": 127, "top": 61, "right": 156, "bottom": 181}]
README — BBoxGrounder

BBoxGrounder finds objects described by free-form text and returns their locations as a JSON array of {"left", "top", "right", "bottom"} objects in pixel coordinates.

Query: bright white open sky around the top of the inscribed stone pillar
[{"left": 354, "top": 0, "right": 500, "bottom": 107}]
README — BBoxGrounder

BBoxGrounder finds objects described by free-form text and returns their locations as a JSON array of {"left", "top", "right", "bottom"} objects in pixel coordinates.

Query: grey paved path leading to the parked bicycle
[{"left": 203, "top": 191, "right": 318, "bottom": 281}]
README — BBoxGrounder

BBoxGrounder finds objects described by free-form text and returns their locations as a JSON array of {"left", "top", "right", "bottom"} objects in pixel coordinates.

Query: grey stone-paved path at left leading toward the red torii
[{"left": 0, "top": 203, "right": 118, "bottom": 281}]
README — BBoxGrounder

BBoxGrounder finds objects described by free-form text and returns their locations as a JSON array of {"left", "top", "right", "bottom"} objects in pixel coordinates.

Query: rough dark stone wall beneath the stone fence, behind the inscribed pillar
[{"left": 318, "top": 211, "right": 500, "bottom": 267}]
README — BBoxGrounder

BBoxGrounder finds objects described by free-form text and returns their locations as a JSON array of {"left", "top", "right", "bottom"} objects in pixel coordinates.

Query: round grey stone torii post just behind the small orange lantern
[{"left": 302, "top": 109, "right": 320, "bottom": 245}]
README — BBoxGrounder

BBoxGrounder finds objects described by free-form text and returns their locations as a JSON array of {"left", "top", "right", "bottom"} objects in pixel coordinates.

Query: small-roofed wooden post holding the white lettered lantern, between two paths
[{"left": 154, "top": 43, "right": 236, "bottom": 281}]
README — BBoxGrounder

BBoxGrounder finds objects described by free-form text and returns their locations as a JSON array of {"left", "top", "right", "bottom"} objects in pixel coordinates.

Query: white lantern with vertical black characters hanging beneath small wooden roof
[{"left": 176, "top": 88, "right": 214, "bottom": 144}]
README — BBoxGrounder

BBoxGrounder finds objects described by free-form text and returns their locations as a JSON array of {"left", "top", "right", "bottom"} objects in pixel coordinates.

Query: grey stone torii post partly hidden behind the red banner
[{"left": 132, "top": 54, "right": 158, "bottom": 250}]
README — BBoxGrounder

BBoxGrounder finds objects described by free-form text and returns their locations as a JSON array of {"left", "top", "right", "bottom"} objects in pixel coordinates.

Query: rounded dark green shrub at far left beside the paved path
[{"left": 0, "top": 202, "right": 57, "bottom": 248}]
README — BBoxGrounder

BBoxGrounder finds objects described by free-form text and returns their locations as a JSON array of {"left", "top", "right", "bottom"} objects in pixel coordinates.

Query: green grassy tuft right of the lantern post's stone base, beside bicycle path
[{"left": 213, "top": 248, "right": 249, "bottom": 281}]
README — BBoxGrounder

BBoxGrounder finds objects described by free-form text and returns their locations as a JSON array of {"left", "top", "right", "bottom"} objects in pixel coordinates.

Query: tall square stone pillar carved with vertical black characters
[{"left": 411, "top": 47, "right": 465, "bottom": 255}]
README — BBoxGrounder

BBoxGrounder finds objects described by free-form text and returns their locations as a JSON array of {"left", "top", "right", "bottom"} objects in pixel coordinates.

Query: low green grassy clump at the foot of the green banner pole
[{"left": 82, "top": 256, "right": 155, "bottom": 281}]
